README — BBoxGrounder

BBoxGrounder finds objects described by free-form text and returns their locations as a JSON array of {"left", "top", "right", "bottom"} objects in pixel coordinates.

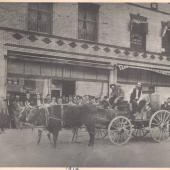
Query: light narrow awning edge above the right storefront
[{"left": 117, "top": 64, "right": 170, "bottom": 76}]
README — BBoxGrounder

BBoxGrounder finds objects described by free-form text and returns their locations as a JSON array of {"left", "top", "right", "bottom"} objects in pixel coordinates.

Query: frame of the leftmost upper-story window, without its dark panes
[{"left": 27, "top": 2, "right": 53, "bottom": 34}]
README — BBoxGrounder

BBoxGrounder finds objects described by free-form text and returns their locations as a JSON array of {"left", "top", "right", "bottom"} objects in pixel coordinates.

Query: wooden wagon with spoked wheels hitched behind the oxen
[{"left": 96, "top": 94, "right": 170, "bottom": 145}]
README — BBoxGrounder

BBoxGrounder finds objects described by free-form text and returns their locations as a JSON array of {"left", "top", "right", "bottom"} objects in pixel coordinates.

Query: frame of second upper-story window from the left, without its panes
[{"left": 77, "top": 3, "right": 100, "bottom": 42}]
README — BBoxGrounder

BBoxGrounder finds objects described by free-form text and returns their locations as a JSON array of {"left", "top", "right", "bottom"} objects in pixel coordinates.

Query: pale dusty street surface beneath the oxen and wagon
[{"left": 0, "top": 129, "right": 170, "bottom": 167}]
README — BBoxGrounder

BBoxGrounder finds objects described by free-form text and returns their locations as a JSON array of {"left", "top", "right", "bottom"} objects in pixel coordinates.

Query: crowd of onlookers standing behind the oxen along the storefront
[{"left": 0, "top": 92, "right": 108, "bottom": 131}]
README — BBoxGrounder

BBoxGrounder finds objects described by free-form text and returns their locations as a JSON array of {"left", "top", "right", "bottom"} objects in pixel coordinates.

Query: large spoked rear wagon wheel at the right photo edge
[{"left": 149, "top": 110, "right": 170, "bottom": 142}]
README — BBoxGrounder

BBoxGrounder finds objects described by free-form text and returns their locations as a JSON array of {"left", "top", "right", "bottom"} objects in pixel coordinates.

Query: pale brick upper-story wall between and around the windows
[{"left": 0, "top": 3, "right": 169, "bottom": 52}]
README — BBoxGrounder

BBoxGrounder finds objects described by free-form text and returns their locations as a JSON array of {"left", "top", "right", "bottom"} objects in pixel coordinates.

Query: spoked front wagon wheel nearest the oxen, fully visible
[{"left": 108, "top": 116, "right": 132, "bottom": 145}]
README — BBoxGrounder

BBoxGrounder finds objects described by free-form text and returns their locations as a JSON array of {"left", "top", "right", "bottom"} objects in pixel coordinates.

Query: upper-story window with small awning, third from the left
[{"left": 130, "top": 14, "right": 148, "bottom": 51}]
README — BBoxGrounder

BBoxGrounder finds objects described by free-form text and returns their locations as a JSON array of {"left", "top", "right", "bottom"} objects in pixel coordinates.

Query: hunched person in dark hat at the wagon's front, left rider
[{"left": 109, "top": 84, "right": 124, "bottom": 108}]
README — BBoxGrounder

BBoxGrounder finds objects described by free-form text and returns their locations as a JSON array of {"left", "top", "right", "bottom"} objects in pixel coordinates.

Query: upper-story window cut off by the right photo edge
[{"left": 161, "top": 21, "right": 170, "bottom": 55}]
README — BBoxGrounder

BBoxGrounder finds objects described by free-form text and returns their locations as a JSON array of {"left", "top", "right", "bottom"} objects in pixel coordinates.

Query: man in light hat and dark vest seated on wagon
[{"left": 130, "top": 82, "right": 142, "bottom": 115}]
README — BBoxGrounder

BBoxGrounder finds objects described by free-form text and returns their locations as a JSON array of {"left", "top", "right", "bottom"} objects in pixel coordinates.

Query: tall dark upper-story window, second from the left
[{"left": 78, "top": 3, "right": 99, "bottom": 41}]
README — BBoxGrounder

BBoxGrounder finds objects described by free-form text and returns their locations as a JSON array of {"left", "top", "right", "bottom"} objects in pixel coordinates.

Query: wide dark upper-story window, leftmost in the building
[{"left": 28, "top": 3, "right": 53, "bottom": 34}]
